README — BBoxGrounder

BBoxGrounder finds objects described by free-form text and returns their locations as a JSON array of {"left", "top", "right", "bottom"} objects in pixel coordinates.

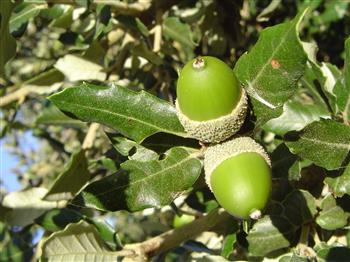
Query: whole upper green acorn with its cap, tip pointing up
[{"left": 176, "top": 56, "right": 247, "bottom": 143}]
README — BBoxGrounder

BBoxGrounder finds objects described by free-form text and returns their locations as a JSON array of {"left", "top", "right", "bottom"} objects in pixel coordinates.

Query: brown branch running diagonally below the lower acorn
[{"left": 124, "top": 208, "right": 232, "bottom": 261}]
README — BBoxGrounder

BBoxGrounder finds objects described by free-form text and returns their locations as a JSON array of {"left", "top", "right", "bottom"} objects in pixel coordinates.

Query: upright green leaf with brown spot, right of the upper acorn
[{"left": 234, "top": 10, "right": 306, "bottom": 125}]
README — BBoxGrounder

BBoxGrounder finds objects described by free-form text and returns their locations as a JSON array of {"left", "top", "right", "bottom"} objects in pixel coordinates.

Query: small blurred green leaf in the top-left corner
[{"left": 10, "top": 4, "right": 47, "bottom": 33}]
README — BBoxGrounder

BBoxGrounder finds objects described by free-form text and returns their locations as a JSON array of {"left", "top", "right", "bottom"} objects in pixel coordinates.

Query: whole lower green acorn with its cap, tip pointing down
[{"left": 204, "top": 137, "right": 271, "bottom": 219}]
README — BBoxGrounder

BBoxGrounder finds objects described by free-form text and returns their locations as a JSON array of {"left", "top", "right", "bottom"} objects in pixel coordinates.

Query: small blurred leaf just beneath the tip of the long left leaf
[{"left": 35, "top": 105, "right": 86, "bottom": 128}]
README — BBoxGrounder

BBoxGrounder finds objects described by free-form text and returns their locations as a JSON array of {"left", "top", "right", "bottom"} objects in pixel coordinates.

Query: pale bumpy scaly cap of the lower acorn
[{"left": 204, "top": 137, "right": 271, "bottom": 191}]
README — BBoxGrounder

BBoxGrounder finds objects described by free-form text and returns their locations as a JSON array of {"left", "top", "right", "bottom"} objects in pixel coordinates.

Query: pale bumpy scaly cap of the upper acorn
[{"left": 175, "top": 88, "right": 248, "bottom": 143}]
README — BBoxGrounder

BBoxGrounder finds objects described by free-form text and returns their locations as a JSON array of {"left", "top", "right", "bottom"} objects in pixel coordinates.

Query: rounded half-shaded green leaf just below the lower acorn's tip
[{"left": 247, "top": 216, "right": 296, "bottom": 256}]
